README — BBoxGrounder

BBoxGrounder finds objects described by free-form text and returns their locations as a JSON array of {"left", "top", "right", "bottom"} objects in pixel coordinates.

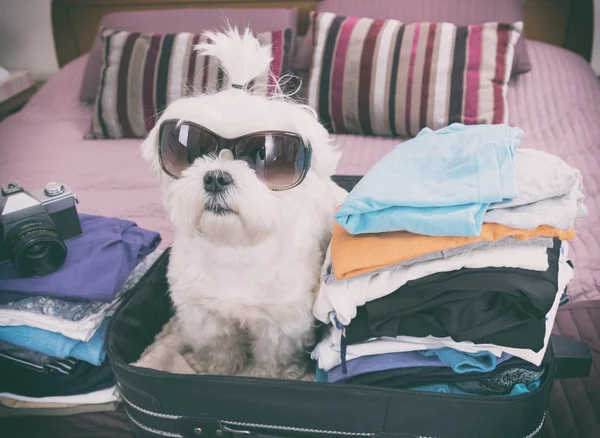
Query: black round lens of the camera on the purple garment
[{"left": 8, "top": 221, "right": 67, "bottom": 277}]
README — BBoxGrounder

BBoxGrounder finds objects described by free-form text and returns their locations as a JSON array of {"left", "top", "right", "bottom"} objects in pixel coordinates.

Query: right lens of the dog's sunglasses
[{"left": 236, "top": 134, "right": 307, "bottom": 189}]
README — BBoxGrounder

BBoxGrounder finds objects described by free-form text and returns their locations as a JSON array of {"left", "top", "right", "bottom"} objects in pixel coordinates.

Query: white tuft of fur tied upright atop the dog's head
[{"left": 194, "top": 27, "right": 273, "bottom": 90}]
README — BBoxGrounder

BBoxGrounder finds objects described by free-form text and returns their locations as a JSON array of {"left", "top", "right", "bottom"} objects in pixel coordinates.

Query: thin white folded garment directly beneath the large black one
[{"left": 311, "top": 290, "right": 562, "bottom": 371}]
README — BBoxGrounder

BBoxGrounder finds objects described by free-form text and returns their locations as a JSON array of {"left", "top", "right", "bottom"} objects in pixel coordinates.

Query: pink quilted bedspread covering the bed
[{"left": 0, "top": 41, "right": 600, "bottom": 301}]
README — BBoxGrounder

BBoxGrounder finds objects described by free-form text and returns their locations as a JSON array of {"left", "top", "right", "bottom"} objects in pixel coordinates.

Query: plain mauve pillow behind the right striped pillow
[{"left": 292, "top": 0, "right": 531, "bottom": 76}]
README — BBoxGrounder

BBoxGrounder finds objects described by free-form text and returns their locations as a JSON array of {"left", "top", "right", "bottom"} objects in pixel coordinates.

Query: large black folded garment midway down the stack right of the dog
[{"left": 346, "top": 239, "right": 560, "bottom": 351}]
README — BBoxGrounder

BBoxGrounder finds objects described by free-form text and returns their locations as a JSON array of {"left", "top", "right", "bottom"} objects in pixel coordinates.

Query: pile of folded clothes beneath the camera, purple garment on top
[{"left": 0, "top": 214, "right": 161, "bottom": 418}]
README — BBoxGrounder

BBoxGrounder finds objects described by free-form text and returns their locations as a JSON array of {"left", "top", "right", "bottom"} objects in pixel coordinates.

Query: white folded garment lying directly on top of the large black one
[{"left": 313, "top": 245, "right": 548, "bottom": 325}]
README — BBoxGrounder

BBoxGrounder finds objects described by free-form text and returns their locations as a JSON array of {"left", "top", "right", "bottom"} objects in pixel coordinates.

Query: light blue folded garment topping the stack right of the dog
[{"left": 335, "top": 123, "right": 523, "bottom": 237}]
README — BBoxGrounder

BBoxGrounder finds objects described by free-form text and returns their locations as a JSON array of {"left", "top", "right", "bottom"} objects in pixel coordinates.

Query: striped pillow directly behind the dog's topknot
[{"left": 88, "top": 29, "right": 292, "bottom": 138}]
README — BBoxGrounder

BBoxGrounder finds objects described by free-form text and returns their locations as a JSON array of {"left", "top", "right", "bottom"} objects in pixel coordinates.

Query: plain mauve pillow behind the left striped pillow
[{"left": 79, "top": 8, "right": 297, "bottom": 101}]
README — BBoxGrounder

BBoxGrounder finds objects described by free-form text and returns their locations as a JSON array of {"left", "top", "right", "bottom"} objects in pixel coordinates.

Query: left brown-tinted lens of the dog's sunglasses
[{"left": 159, "top": 122, "right": 219, "bottom": 178}]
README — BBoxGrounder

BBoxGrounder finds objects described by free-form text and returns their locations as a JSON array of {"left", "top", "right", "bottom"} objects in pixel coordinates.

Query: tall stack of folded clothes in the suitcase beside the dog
[{"left": 312, "top": 124, "right": 587, "bottom": 396}]
